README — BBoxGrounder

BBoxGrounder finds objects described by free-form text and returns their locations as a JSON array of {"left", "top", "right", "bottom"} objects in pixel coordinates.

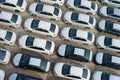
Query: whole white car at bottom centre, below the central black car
[{"left": 53, "top": 62, "right": 91, "bottom": 80}]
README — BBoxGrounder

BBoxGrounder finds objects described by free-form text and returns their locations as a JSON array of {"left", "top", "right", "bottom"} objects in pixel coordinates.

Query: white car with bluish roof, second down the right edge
[{"left": 99, "top": 6, "right": 120, "bottom": 21}]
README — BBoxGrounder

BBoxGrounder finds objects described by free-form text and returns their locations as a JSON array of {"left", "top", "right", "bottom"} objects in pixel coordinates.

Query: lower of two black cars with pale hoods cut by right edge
[{"left": 95, "top": 52, "right": 120, "bottom": 69}]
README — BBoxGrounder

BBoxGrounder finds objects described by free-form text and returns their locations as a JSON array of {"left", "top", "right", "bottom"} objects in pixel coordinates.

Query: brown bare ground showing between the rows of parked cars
[{"left": 0, "top": 0, "right": 120, "bottom": 80}]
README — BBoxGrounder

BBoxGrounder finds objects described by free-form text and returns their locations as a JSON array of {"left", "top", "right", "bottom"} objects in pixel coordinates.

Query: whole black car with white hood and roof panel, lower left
[{"left": 13, "top": 53, "right": 51, "bottom": 72}]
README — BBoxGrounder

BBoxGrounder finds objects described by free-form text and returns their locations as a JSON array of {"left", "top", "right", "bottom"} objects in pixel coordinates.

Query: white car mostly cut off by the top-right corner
[{"left": 100, "top": 0, "right": 120, "bottom": 8}]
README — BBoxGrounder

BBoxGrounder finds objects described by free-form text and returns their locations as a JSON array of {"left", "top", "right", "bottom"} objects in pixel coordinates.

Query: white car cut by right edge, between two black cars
[{"left": 96, "top": 36, "right": 120, "bottom": 52}]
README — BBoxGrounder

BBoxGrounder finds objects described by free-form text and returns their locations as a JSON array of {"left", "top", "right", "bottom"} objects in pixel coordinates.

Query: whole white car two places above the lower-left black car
[{"left": 24, "top": 18, "right": 59, "bottom": 37}]
